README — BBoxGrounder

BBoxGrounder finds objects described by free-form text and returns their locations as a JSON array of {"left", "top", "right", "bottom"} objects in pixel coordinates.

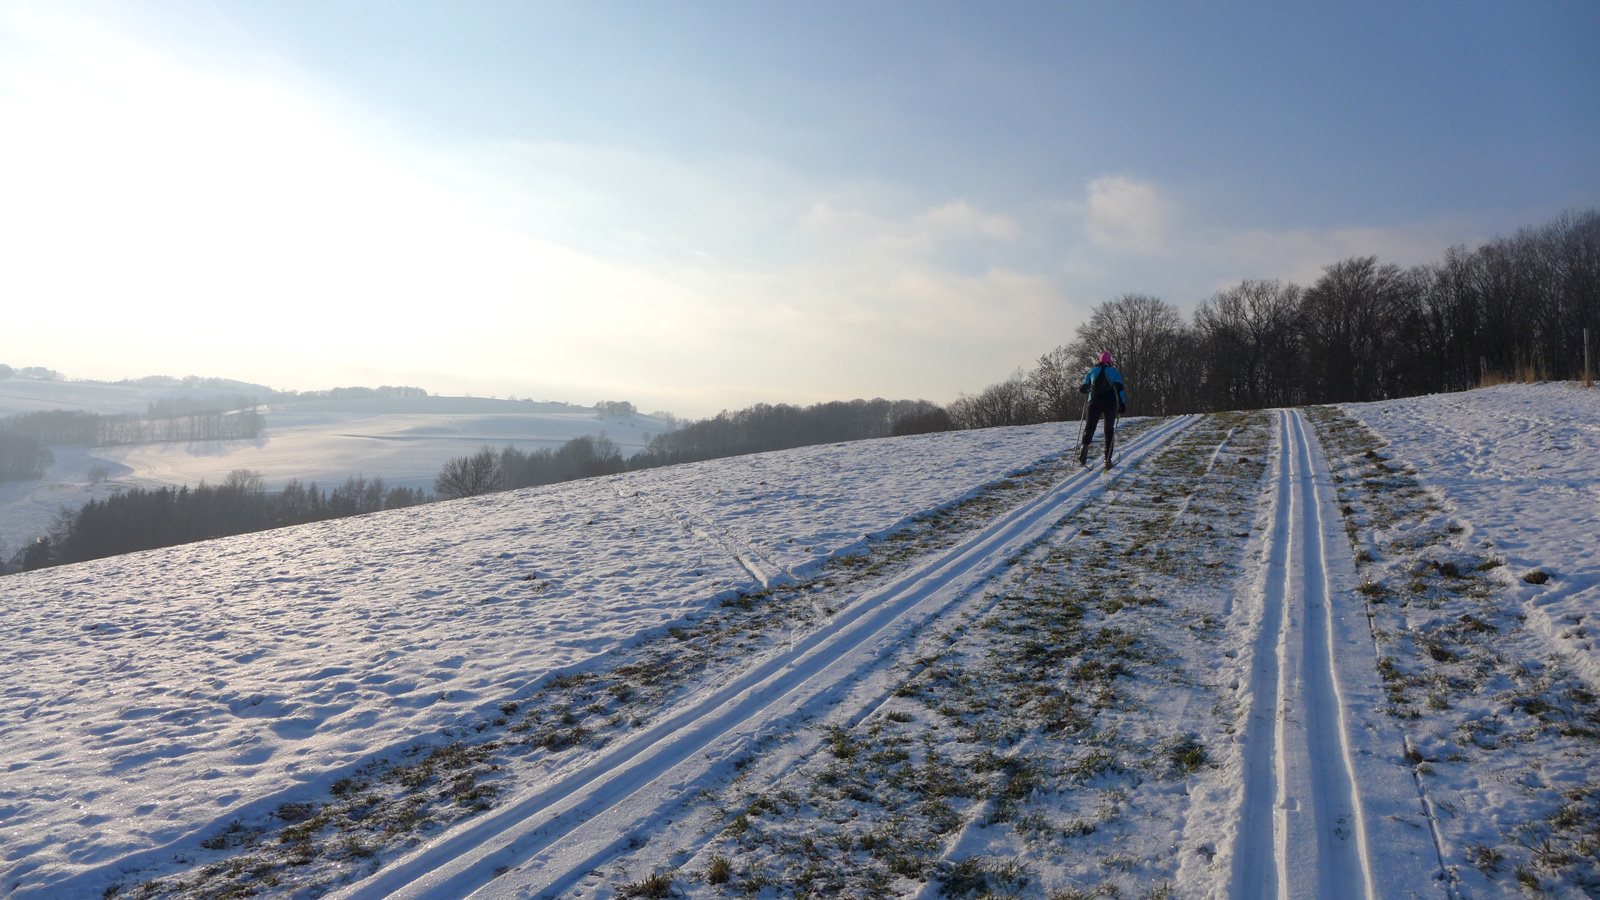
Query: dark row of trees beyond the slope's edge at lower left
[{"left": 22, "top": 469, "right": 429, "bottom": 570}]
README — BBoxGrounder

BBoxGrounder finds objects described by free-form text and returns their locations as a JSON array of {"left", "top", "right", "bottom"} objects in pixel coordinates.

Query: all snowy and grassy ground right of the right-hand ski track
[{"left": 1338, "top": 383, "right": 1600, "bottom": 898}]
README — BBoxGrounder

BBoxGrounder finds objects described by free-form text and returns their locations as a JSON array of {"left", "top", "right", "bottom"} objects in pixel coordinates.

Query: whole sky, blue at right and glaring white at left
[{"left": 0, "top": 0, "right": 1600, "bottom": 415}]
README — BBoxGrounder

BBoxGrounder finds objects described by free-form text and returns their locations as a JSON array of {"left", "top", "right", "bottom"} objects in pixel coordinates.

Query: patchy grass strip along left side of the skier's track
[{"left": 93, "top": 423, "right": 1147, "bottom": 900}]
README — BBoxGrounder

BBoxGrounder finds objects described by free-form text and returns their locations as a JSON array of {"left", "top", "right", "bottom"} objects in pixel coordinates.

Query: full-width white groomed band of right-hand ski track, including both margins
[{"left": 1222, "top": 410, "right": 1446, "bottom": 900}]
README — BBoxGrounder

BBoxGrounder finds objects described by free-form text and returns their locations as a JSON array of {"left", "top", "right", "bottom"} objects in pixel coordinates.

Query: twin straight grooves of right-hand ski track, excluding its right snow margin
[{"left": 1227, "top": 410, "right": 1374, "bottom": 900}]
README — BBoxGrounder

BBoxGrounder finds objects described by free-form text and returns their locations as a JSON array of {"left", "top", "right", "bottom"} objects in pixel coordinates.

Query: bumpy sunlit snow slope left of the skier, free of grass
[{"left": 0, "top": 424, "right": 1074, "bottom": 894}]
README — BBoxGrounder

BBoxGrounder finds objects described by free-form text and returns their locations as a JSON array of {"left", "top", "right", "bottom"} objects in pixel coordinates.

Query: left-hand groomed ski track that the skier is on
[{"left": 330, "top": 416, "right": 1194, "bottom": 900}]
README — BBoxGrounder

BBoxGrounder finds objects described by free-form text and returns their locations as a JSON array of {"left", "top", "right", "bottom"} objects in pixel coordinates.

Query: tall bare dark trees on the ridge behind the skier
[{"left": 949, "top": 210, "right": 1600, "bottom": 428}]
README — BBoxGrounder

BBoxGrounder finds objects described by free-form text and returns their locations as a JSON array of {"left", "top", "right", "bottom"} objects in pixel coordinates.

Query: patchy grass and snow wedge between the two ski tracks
[{"left": 601, "top": 415, "right": 1269, "bottom": 898}]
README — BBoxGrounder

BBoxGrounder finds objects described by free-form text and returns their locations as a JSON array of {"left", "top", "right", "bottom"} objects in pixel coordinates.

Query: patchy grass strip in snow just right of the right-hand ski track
[{"left": 1312, "top": 407, "right": 1600, "bottom": 897}]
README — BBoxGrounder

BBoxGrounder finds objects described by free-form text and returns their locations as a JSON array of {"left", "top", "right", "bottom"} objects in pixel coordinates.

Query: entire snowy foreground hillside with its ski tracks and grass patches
[{"left": 0, "top": 384, "right": 1600, "bottom": 900}]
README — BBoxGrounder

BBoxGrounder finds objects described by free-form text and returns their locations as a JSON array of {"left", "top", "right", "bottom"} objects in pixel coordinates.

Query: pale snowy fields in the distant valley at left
[{"left": 0, "top": 378, "right": 669, "bottom": 557}]
